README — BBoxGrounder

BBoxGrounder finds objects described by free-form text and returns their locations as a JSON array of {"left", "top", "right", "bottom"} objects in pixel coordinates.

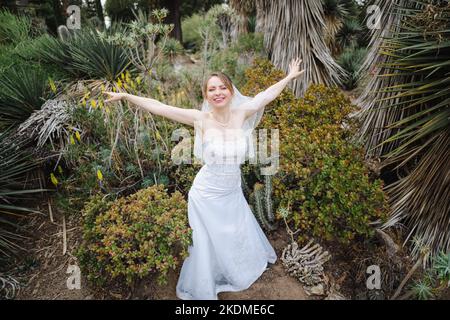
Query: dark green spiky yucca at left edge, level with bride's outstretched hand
[{"left": 0, "top": 66, "right": 50, "bottom": 129}]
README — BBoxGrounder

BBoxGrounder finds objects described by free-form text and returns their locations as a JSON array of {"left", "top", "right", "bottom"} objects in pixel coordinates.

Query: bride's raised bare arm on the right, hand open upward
[{"left": 239, "top": 58, "right": 305, "bottom": 118}]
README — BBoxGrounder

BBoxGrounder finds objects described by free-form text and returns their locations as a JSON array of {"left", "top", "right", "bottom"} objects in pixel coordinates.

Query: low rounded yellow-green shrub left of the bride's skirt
[{"left": 77, "top": 185, "right": 191, "bottom": 284}]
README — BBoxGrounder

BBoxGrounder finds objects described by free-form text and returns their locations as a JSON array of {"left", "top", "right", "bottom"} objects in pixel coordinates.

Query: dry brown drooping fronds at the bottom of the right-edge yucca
[{"left": 384, "top": 129, "right": 450, "bottom": 262}]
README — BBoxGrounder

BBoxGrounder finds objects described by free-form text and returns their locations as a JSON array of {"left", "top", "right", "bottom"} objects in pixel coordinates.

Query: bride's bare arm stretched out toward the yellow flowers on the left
[{"left": 105, "top": 92, "right": 202, "bottom": 126}]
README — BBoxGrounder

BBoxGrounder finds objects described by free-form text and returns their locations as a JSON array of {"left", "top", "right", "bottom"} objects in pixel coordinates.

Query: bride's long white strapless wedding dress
[{"left": 176, "top": 134, "right": 277, "bottom": 300}]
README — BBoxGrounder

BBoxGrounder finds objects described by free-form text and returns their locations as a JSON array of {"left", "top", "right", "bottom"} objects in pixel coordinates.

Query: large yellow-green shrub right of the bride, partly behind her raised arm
[{"left": 243, "top": 59, "right": 387, "bottom": 243}]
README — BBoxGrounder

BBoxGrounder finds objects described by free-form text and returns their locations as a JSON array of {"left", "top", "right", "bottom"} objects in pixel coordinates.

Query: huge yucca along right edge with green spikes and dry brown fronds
[{"left": 359, "top": 0, "right": 450, "bottom": 256}]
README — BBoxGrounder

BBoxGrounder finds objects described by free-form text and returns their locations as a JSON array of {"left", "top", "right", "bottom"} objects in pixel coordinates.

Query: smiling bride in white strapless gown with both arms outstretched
[{"left": 105, "top": 58, "right": 304, "bottom": 300}]
